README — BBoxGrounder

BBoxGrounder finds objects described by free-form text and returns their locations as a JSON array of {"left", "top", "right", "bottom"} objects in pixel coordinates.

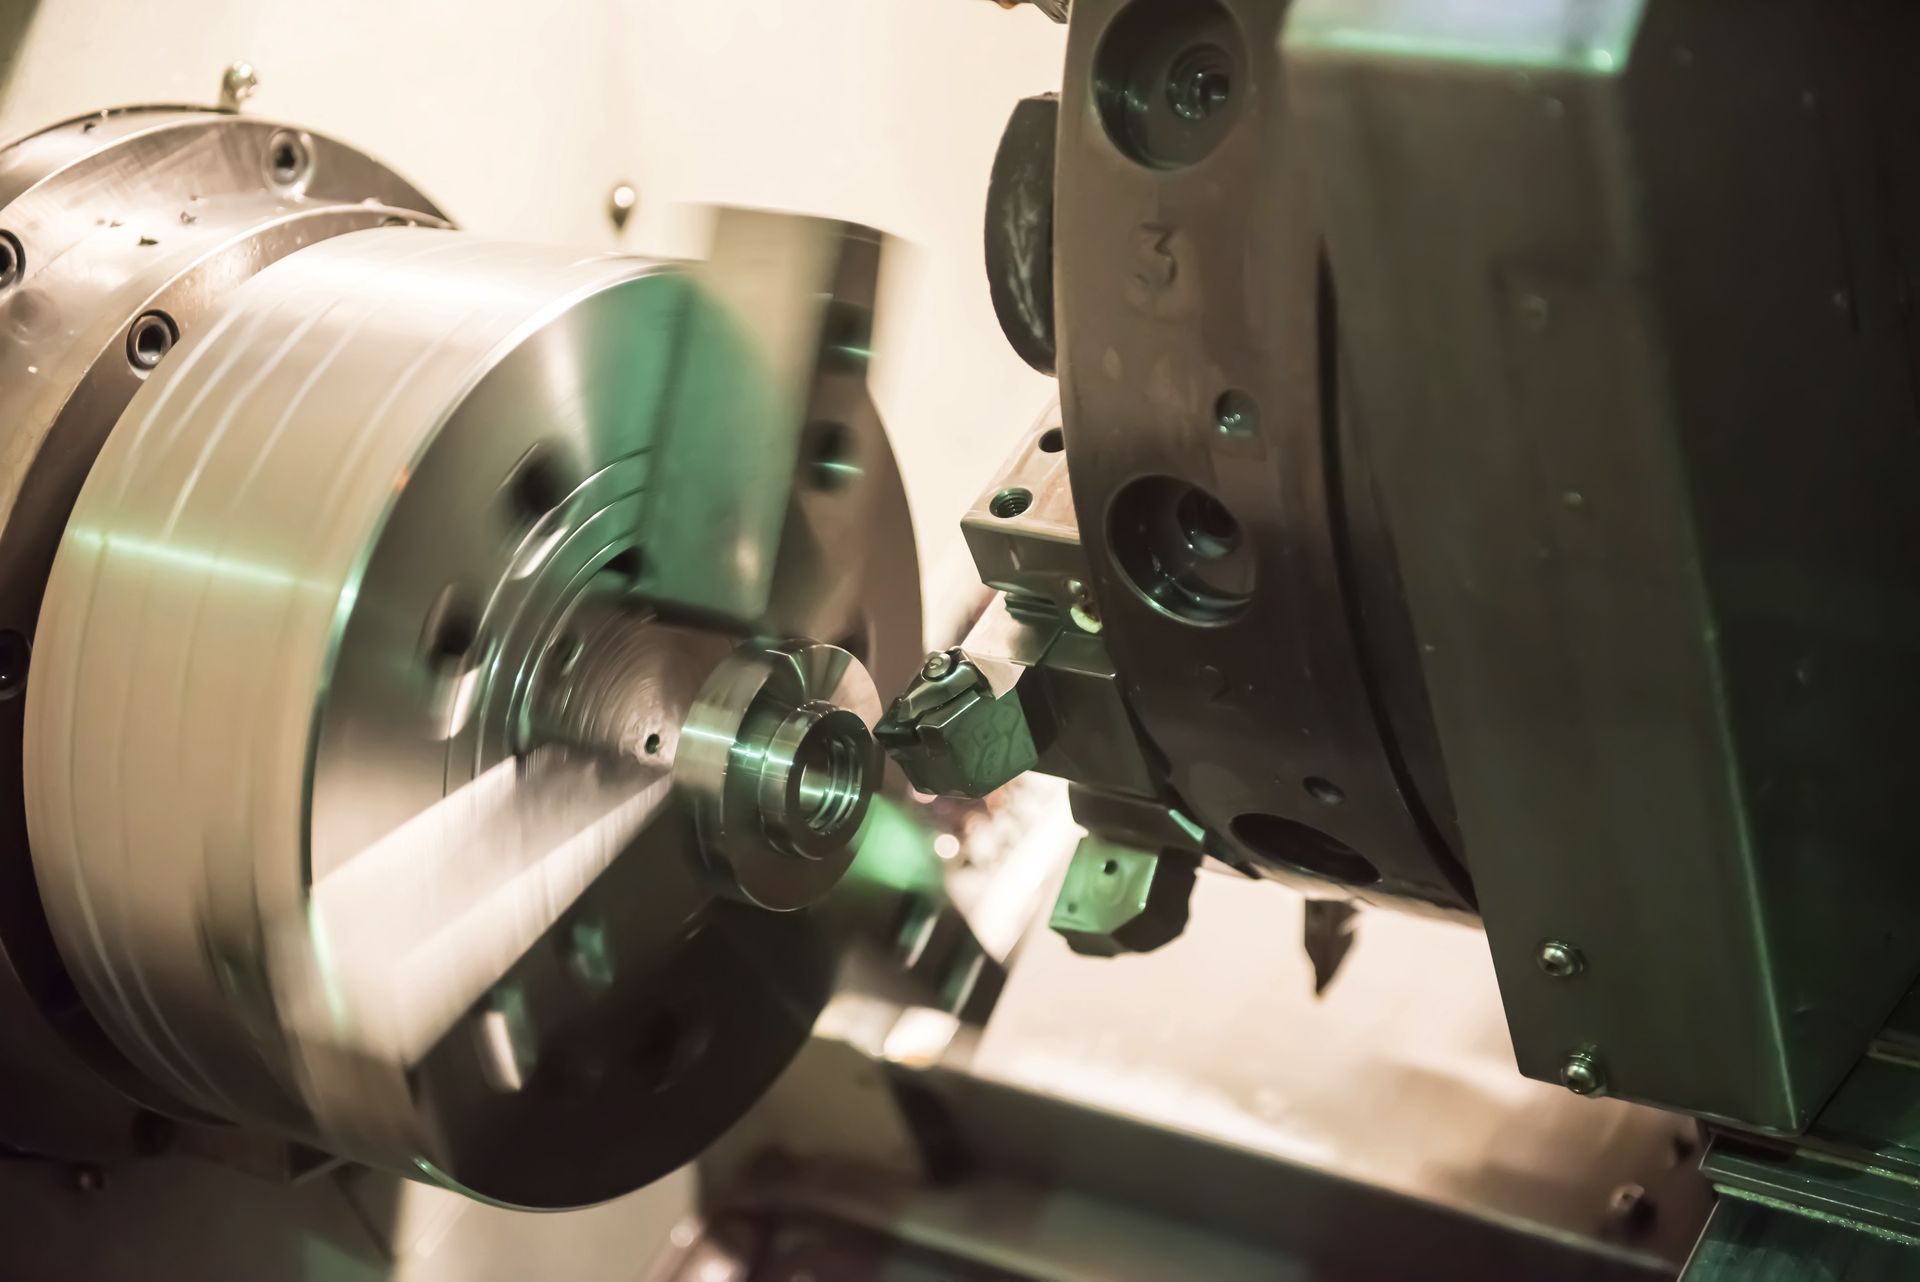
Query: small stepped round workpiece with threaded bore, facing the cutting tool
[{"left": 674, "top": 643, "right": 881, "bottom": 912}]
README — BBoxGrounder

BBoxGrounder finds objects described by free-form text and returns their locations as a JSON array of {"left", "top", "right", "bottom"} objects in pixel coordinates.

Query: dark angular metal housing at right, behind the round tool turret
[{"left": 1284, "top": 0, "right": 1920, "bottom": 1132}]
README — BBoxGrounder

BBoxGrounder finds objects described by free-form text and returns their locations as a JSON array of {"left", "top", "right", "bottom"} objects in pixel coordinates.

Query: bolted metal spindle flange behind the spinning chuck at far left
[{"left": 0, "top": 107, "right": 440, "bottom": 1157}]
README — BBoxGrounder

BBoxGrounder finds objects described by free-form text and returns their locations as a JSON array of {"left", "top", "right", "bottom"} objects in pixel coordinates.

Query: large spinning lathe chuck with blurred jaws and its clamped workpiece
[{"left": 0, "top": 105, "right": 918, "bottom": 1207}]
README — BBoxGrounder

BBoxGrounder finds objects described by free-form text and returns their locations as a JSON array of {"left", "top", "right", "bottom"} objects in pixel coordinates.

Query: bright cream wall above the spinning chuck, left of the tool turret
[{"left": 0, "top": 0, "right": 1066, "bottom": 597}]
